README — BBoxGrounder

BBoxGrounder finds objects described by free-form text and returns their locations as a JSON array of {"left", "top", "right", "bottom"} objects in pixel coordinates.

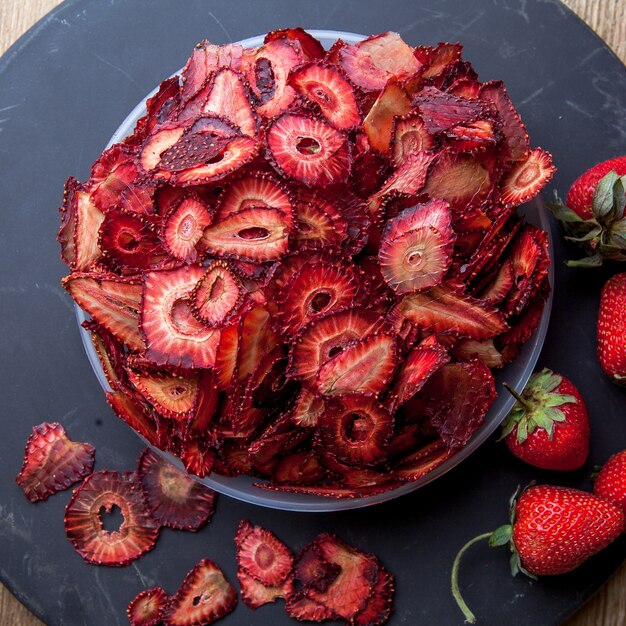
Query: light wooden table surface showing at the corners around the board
[{"left": 0, "top": 0, "right": 626, "bottom": 626}]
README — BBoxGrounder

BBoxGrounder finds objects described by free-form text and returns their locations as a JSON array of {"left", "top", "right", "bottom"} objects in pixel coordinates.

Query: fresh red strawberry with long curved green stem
[{"left": 451, "top": 485, "right": 625, "bottom": 624}]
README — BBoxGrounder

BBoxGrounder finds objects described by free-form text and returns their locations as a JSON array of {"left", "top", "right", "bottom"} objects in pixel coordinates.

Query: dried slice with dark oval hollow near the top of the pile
[{"left": 244, "top": 38, "right": 304, "bottom": 118}]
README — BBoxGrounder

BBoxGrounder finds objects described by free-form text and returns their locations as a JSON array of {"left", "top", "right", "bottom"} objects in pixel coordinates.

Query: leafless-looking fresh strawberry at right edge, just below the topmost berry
[{"left": 598, "top": 272, "right": 626, "bottom": 385}]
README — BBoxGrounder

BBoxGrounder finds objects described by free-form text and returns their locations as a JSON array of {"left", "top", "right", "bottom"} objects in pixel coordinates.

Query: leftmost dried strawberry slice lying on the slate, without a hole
[{"left": 15, "top": 422, "right": 96, "bottom": 502}]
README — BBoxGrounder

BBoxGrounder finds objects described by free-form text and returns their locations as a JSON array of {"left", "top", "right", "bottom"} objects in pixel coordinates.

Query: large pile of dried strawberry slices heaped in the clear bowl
[{"left": 58, "top": 28, "right": 554, "bottom": 498}]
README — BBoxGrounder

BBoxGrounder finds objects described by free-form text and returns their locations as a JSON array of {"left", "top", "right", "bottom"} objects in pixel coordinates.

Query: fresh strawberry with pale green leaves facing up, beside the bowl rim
[{"left": 502, "top": 369, "right": 589, "bottom": 471}]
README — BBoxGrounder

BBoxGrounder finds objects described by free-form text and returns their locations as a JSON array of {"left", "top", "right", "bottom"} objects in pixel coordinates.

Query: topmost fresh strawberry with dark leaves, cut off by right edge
[{"left": 548, "top": 156, "right": 626, "bottom": 267}]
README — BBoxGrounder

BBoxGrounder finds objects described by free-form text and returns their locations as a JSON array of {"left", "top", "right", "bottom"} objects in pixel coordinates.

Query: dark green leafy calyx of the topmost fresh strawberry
[{"left": 548, "top": 170, "right": 626, "bottom": 267}]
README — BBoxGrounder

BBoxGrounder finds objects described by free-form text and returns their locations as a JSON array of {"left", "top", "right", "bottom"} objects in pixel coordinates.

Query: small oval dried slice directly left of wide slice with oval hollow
[{"left": 162, "top": 194, "right": 213, "bottom": 263}]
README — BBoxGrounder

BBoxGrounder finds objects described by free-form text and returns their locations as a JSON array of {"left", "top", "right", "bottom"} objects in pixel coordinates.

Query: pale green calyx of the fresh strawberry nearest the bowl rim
[{"left": 500, "top": 368, "right": 578, "bottom": 443}]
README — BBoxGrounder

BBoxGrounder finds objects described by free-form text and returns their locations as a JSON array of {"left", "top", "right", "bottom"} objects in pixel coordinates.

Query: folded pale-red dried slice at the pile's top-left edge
[{"left": 181, "top": 39, "right": 244, "bottom": 103}]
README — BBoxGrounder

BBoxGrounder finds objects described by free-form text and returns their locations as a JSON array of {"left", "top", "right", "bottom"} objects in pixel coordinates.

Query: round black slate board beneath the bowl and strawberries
[{"left": 0, "top": 0, "right": 626, "bottom": 626}]
